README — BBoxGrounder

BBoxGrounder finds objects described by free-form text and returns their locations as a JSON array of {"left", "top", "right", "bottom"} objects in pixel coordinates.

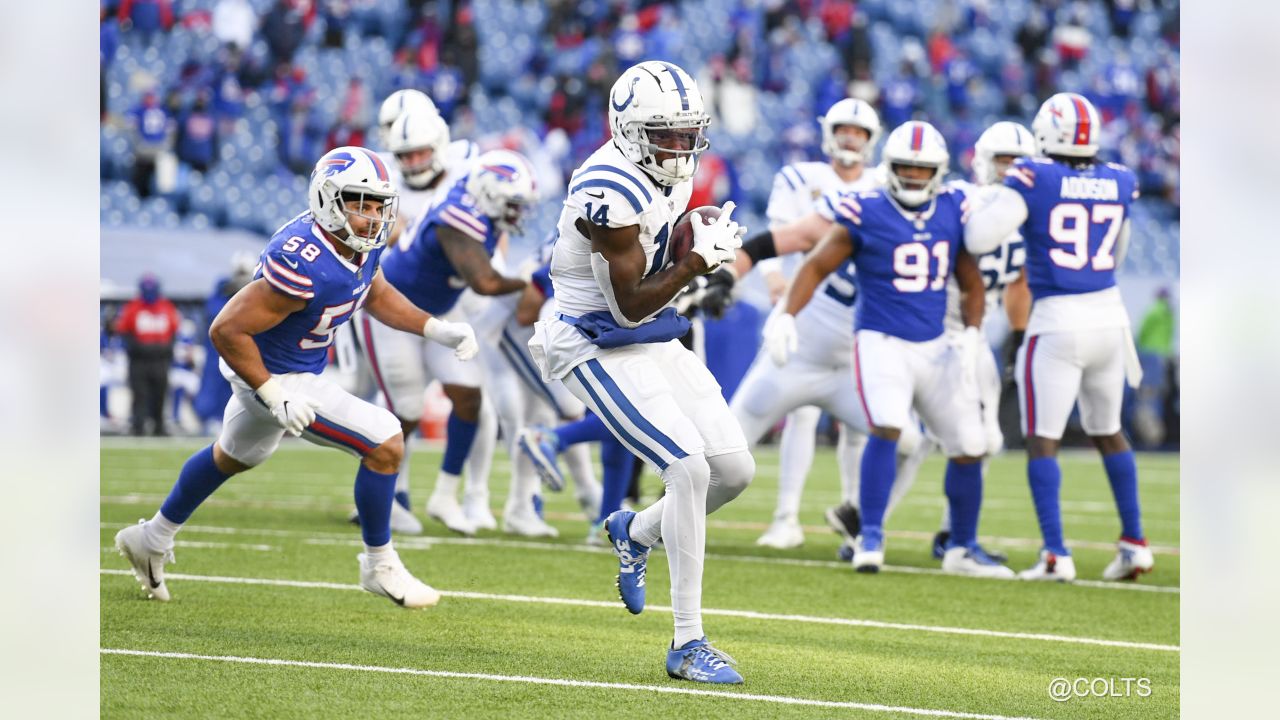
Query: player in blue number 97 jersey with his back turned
[{"left": 1005, "top": 92, "right": 1155, "bottom": 580}]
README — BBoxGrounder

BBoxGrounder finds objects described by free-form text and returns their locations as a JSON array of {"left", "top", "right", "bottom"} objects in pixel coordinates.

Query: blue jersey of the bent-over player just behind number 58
[{"left": 383, "top": 178, "right": 499, "bottom": 315}]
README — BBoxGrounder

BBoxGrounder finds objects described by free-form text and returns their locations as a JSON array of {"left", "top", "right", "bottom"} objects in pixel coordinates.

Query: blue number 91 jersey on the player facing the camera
[{"left": 837, "top": 188, "right": 964, "bottom": 342}]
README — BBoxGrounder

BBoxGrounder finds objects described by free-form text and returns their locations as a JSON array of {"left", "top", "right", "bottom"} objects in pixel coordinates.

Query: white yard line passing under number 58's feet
[{"left": 99, "top": 569, "right": 1180, "bottom": 652}]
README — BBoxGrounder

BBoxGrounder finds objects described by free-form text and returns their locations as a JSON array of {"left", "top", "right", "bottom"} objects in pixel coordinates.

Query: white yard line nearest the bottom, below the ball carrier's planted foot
[{"left": 100, "top": 647, "right": 1049, "bottom": 720}]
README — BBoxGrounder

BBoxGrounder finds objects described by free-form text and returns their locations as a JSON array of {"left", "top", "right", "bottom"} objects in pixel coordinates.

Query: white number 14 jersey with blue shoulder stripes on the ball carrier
[{"left": 530, "top": 141, "right": 692, "bottom": 382}]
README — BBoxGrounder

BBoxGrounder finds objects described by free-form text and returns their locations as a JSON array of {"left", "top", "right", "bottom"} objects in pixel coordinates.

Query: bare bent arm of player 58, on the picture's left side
[{"left": 209, "top": 278, "right": 307, "bottom": 389}]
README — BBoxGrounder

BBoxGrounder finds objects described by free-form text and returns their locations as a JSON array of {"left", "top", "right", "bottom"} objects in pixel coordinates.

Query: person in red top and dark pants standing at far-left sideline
[{"left": 115, "top": 273, "right": 180, "bottom": 436}]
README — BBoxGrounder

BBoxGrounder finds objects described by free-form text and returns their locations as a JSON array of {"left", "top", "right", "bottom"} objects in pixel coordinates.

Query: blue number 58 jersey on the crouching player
[{"left": 253, "top": 213, "right": 383, "bottom": 374}]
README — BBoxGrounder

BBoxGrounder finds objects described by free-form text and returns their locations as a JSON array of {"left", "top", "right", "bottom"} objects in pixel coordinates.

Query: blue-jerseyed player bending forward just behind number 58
[{"left": 356, "top": 149, "right": 534, "bottom": 536}]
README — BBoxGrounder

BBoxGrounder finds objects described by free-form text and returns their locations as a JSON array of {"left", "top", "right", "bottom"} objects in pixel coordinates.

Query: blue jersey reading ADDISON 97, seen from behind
[{"left": 1005, "top": 158, "right": 1138, "bottom": 299}]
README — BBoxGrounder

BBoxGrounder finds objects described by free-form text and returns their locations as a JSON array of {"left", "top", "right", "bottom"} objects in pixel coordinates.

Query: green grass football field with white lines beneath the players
[{"left": 101, "top": 439, "right": 1180, "bottom": 719}]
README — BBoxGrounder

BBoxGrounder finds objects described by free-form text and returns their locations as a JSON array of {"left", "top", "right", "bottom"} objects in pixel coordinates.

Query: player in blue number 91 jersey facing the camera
[{"left": 765, "top": 122, "right": 1018, "bottom": 578}]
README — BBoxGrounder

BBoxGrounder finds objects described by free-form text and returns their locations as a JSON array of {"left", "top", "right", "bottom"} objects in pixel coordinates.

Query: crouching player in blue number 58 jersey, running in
[{"left": 115, "top": 147, "right": 477, "bottom": 607}]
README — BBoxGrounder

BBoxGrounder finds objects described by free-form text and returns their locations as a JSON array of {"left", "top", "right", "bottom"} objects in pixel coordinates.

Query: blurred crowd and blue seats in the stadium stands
[{"left": 101, "top": 0, "right": 1180, "bottom": 269}]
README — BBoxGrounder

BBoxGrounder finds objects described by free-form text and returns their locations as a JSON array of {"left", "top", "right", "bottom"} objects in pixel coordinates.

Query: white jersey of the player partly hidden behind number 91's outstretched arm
[{"left": 762, "top": 163, "right": 879, "bottom": 364}]
